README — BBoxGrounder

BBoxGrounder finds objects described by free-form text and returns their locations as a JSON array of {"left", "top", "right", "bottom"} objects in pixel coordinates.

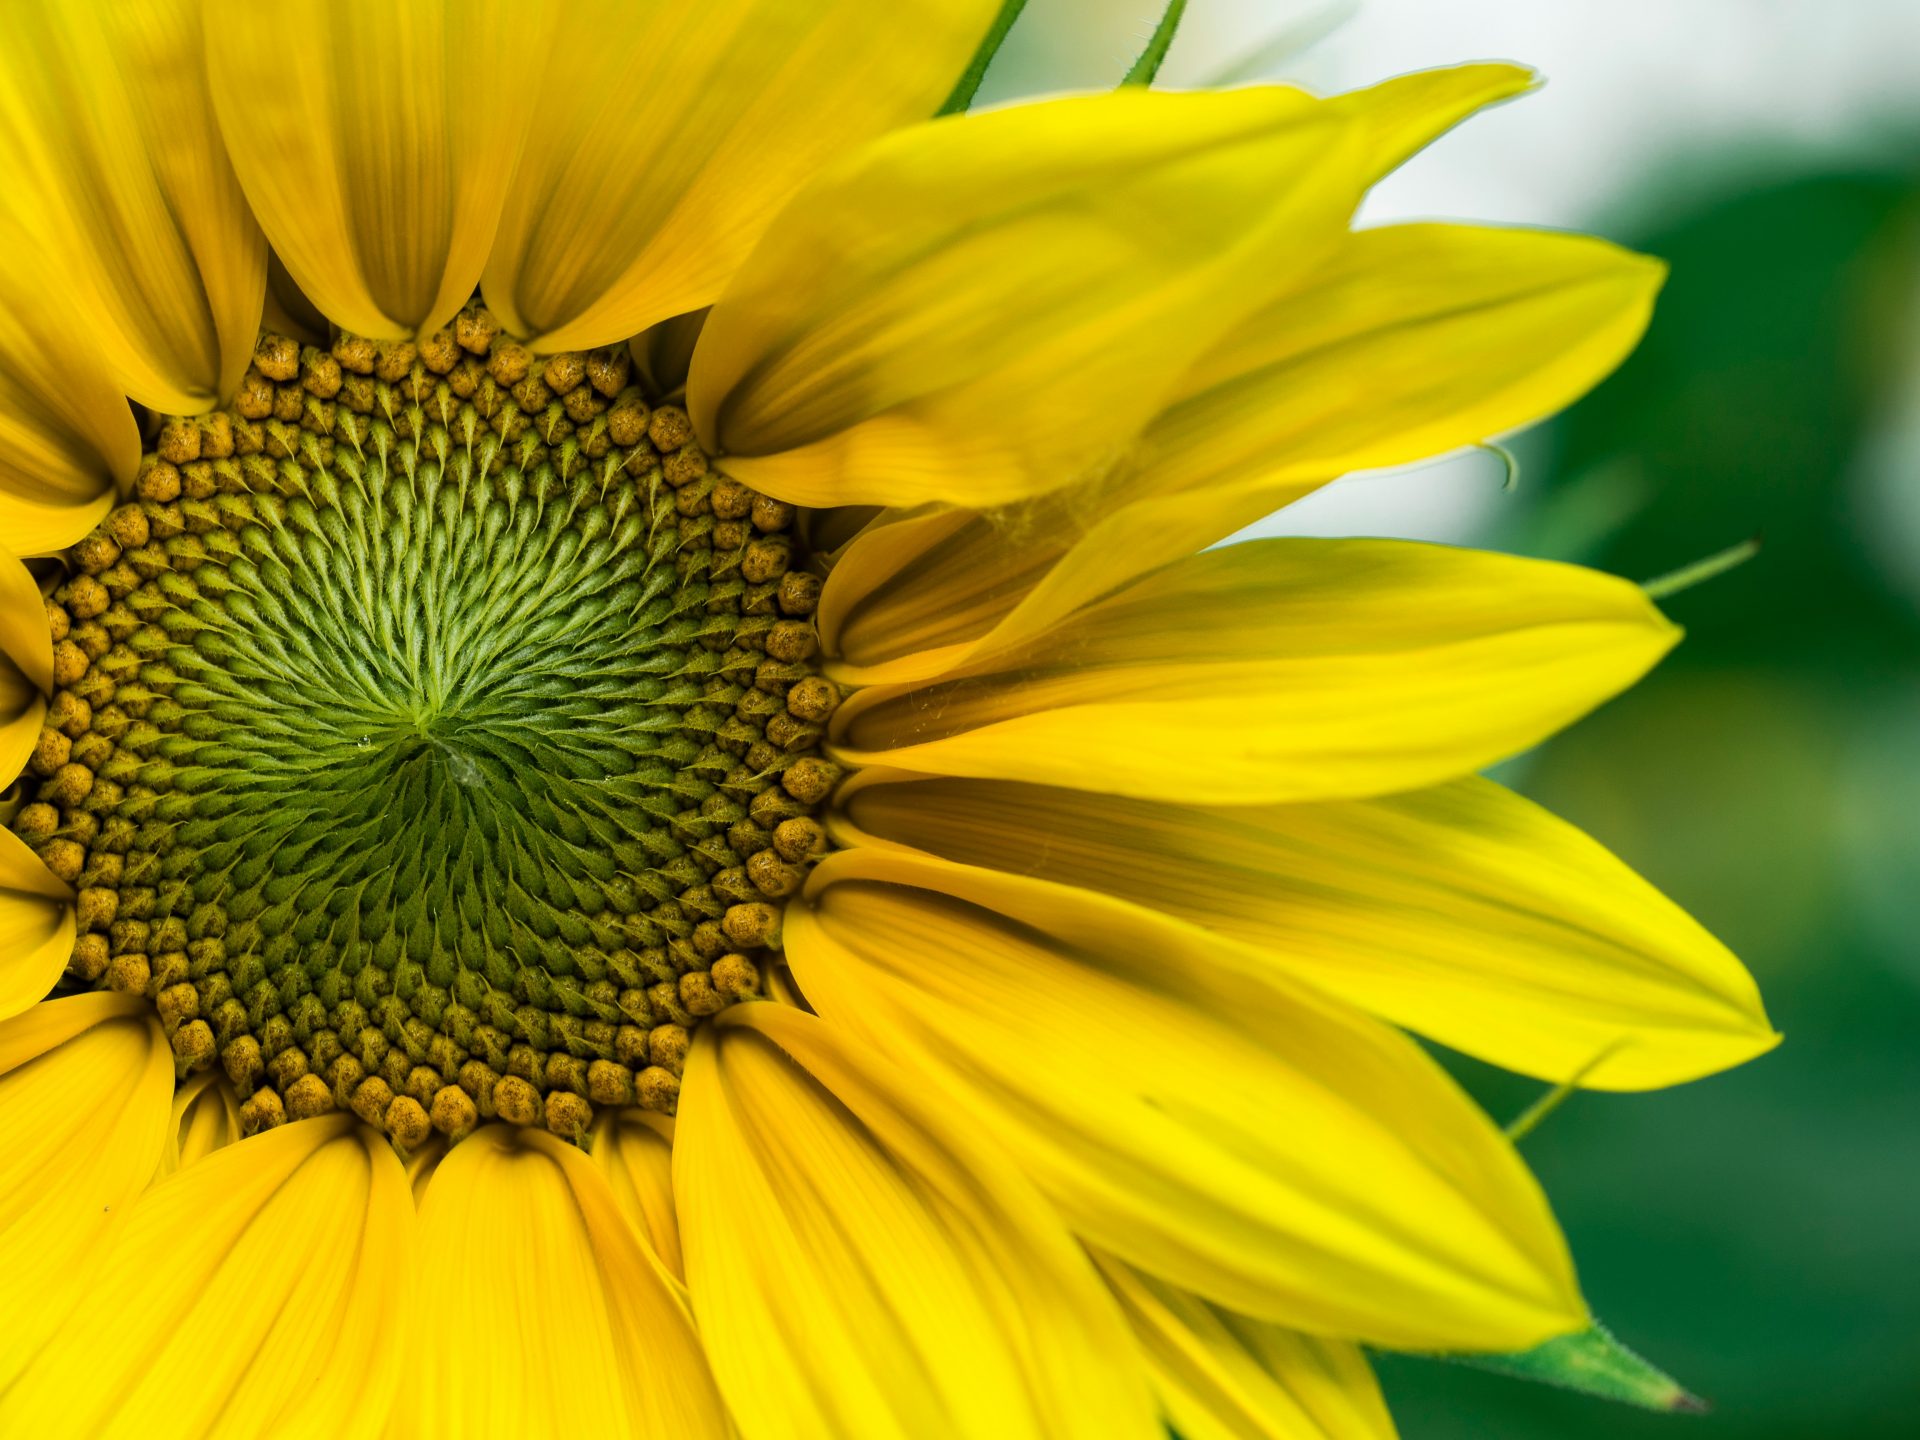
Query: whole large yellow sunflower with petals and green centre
[{"left": 0, "top": 0, "right": 1774, "bottom": 1440}]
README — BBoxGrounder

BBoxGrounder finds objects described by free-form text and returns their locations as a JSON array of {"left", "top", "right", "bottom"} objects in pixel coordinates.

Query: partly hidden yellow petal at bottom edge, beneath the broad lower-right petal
[{"left": 1100, "top": 1256, "right": 1398, "bottom": 1440}]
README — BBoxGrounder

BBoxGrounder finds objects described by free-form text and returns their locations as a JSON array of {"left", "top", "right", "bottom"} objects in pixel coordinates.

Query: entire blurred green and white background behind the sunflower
[{"left": 987, "top": 0, "right": 1920, "bottom": 1440}]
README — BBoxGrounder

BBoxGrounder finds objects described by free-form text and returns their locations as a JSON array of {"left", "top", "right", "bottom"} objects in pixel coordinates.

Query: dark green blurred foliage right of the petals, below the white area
[{"left": 1388, "top": 160, "right": 1920, "bottom": 1440}]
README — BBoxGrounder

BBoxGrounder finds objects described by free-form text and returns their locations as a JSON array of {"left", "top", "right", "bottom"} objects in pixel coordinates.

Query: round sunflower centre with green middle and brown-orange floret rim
[{"left": 13, "top": 311, "right": 837, "bottom": 1146}]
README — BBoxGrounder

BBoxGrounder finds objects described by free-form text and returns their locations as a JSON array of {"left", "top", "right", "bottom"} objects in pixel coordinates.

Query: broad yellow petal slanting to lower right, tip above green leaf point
[{"left": 785, "top": 851, "right": 1586, "bottom": 1350}]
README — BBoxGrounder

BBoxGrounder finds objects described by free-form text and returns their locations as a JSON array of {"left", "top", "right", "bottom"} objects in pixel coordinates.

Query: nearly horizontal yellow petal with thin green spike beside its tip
[{"left": 835, "top": 540, "right": 1678, "bottom": 804}]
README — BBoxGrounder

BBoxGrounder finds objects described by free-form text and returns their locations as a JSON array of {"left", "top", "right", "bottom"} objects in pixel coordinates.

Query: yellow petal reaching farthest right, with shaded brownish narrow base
[{"left": 839, "top": 780, "right": 1780, "bottom": 1091}]
